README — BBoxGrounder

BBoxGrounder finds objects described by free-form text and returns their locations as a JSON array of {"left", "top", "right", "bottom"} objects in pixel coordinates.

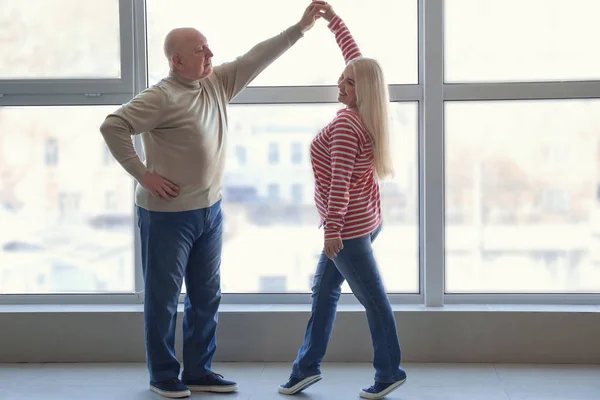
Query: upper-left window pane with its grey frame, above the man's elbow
[{"left": 0, "top": 0, "right": 134, "bottom": 97}]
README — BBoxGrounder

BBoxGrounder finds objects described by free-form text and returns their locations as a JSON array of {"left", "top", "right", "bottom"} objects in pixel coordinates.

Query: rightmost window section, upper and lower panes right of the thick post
[{"left": 444, "top": 0, "right": 600, "bottom": 296}]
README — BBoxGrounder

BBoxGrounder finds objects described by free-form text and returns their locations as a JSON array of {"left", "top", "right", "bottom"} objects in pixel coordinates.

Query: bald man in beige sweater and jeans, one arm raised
[{"left": 100, "top": 1, "right": 325, "bottom": 398}]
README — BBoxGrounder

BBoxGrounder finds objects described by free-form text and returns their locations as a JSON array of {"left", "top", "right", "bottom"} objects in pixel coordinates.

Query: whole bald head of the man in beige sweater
[{"left": 163, "top": 28, "right": 213, "bottom": 79}]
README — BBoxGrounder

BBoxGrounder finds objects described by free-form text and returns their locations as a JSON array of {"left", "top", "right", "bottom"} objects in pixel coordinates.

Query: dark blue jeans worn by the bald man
[{"left": 137, "top": 201, "right": 223, "bottom": 382}]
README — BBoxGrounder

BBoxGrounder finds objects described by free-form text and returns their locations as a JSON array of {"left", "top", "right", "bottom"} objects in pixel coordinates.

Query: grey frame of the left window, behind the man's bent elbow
[{"left": 0, "top": 0, "right": 146, "bottom": 309}]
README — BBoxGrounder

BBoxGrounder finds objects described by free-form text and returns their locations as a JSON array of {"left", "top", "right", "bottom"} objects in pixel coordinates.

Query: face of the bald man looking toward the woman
[{"left": 177, "top": 31, "right": 213, "bottom": 80}]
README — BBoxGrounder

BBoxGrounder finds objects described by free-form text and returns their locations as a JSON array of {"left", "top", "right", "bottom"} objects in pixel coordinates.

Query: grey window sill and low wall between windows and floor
[{"left": 0, "top": 304, "right": 600, "bottom": 364}]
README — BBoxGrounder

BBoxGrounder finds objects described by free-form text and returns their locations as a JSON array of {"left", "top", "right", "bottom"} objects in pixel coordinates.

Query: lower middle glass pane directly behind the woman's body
[{"left": 221, "top": 103, "right": 419, "bottom": 293}]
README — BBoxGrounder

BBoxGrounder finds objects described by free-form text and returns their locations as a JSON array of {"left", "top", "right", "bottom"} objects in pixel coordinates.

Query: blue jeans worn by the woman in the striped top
[{"left": 291, "top": 226, "right": 406, "bottom": 383}]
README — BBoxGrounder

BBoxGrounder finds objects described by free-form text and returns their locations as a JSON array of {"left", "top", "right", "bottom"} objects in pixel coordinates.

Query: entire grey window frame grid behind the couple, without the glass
[{"left": 0, "top": 0, "right": 600, "bottom": 307}]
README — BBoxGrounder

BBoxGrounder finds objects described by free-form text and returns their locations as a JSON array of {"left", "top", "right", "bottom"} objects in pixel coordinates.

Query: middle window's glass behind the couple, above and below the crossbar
[{"left": 147, "top": 0, "right": 420, "bottom": 293}]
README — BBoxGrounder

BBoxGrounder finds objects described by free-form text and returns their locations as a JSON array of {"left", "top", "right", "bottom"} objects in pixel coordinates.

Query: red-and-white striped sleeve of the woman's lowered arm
[{"left": 325, "top": 114, "right": 359, "bottom": 240}]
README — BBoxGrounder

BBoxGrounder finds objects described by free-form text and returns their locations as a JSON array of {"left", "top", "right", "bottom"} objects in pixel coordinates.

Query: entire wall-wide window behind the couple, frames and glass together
[{"left": 0, "top": 0, "right": 600, "bottom": 306}]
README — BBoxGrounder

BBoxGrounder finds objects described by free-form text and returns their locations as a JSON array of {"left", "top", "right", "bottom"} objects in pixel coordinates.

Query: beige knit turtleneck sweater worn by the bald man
[{"left": 100, "top": 25, "right": 303, "bottom": 212}]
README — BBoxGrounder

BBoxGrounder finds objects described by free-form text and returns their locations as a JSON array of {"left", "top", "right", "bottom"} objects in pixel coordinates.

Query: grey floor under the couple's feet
[{"left": 0, "top": 363, "right": 600, "bottom": 400}]
